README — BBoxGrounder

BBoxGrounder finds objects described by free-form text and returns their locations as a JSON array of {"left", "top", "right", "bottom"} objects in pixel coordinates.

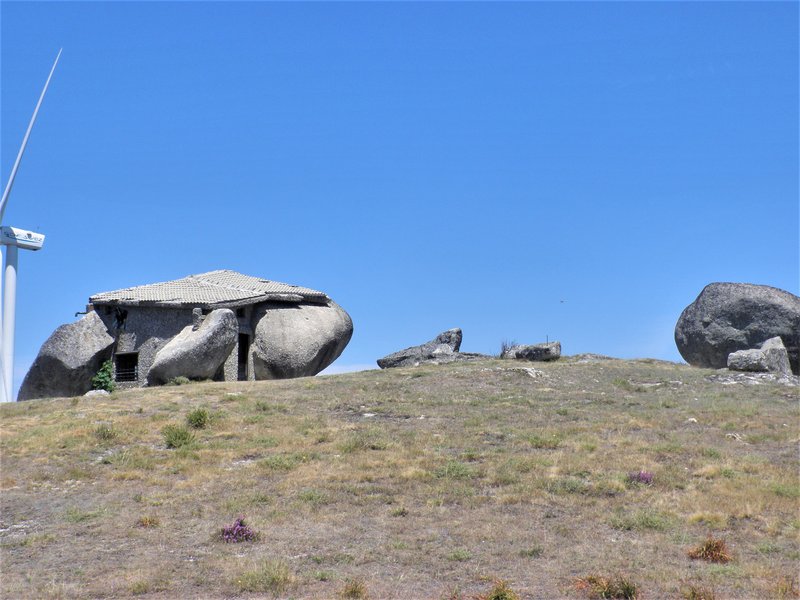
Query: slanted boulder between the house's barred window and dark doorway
[{"left": 147, "top": 308, "right": 239, "bottom": 385}]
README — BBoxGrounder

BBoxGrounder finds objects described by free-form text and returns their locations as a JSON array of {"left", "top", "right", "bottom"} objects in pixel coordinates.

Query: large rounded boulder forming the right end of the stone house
[{"left": 252, "top": 300, "right": 353, "bottom": 379}]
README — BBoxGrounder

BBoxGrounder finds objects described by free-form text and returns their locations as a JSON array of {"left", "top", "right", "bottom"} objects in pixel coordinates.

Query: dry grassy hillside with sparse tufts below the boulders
[{"left": 0, "top": 358, "right": 800, "bottom": 599}]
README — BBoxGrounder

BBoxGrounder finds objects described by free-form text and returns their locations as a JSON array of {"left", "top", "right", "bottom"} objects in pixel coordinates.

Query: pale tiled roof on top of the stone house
[{"left": 89, "top": 270, "right": 328, "bottom": 306}]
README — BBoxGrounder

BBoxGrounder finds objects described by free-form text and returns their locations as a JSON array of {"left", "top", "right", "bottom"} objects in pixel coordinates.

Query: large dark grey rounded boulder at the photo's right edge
[{"left": 675, "top": 283, "right": 800, "bottom": 374}]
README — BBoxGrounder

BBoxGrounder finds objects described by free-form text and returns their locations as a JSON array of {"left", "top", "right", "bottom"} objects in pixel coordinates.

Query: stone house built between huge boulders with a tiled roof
[{"left": 20, "top": 270, "right": 353, "bottom": 399}]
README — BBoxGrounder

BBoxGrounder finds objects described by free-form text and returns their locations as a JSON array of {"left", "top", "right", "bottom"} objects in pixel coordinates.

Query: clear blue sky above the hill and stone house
[{"left": 0, "top": 2, "right": 800, "bottom": 398}]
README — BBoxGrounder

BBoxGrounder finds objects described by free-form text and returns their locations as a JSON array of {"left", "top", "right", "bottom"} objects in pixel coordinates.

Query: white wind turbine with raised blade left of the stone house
[{"left": 0, "top": 50, "right": 61, "bottom": 402}]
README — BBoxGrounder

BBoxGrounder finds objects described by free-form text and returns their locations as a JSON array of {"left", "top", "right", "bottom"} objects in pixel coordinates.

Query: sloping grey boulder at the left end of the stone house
[{"left": 18, "top": 311, "right": 114, "bottom": 400}]
